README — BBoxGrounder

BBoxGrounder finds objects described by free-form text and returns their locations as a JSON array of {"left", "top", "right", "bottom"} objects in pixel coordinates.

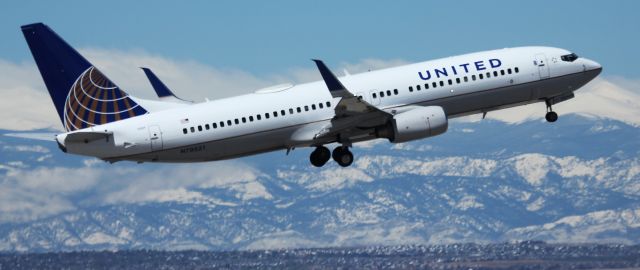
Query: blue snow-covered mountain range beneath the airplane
[{"left": 0, "top": 78, "right": 640, "bottom": 251}]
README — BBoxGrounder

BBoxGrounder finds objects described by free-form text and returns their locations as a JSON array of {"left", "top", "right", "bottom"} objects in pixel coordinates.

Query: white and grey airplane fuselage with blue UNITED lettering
[{"left": 57, "top": 47, "right": 601, "bottom": 162}]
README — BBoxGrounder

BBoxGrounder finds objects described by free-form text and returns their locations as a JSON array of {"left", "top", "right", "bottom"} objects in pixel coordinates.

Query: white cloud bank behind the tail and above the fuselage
[{"left": 0, "top": 48, "right": 405, "bottom": 133}]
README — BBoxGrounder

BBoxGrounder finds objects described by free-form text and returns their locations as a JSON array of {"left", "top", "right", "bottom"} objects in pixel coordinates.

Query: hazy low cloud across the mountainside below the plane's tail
[{"left": 0, "top": 159, "right": 273, "bottom": 223}]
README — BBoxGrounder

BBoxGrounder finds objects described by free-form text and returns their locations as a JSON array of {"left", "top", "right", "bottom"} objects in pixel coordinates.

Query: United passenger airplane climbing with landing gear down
[{"left": 21, "top": 23, "right": 602, "bottom": 167}]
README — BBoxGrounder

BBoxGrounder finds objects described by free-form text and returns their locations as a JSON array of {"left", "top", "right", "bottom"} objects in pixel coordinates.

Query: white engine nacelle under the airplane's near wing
[{"left": 376, "top": 106, "right": 449, "bottom": 143}]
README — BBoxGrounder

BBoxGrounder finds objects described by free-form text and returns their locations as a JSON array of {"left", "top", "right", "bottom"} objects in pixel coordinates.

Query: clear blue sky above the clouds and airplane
[{"left": 0, "top": 1, "right": 640, "bottom": 78}]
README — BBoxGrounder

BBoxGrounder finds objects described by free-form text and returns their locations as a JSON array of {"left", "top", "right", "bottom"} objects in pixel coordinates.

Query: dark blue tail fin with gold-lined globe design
[{"left": 22, "top": 23, "right": 147, "bottom": 131}]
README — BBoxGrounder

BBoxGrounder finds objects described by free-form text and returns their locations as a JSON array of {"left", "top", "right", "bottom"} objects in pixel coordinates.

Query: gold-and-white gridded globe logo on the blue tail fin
[{"left": 64, "top": 66, "right": 147, "bottom": 131}]
